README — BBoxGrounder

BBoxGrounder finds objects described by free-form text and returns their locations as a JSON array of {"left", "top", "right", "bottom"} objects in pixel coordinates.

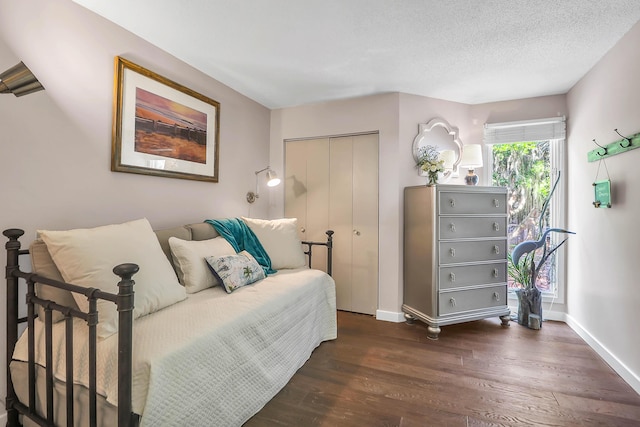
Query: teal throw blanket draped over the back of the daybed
[{"left": 205, "top": 218, "right": 277, "bottom": 274}]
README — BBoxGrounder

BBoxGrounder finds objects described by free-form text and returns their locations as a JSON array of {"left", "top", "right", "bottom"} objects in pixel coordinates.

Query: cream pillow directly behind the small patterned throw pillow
[{"left": 169, "top": 237, "right": 236, "bottom": 294}]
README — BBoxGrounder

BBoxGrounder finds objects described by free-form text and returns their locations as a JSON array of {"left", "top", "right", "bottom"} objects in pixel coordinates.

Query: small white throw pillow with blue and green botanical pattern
[{"left": 206, "top": 251, "right": 266, "bottom": 294}]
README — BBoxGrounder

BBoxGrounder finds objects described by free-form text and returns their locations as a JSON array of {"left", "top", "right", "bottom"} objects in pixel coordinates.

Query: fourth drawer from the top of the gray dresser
[{"left": 438, "top": 262, "right": 507, "bottom": 290}]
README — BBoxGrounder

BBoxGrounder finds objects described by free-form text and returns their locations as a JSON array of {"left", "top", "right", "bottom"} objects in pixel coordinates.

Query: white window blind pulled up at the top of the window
[{"left": 483, "top": 116, "right": 566, "bottom": 144}]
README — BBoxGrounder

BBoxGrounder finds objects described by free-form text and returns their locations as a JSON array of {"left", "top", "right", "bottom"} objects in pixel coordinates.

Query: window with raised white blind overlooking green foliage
[{"left": 484, "top": 118, "right": 566, "bottom": 302}]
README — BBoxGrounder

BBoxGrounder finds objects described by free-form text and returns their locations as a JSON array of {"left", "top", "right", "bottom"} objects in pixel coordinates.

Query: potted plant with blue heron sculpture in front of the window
[{"left": 508, "top": 172, "right": 575, "bottom": 329}]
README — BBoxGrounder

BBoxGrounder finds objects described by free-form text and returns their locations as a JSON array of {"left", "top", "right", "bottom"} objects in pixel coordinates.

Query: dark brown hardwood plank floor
[{"left": 245, "top": 312, "right": 640, "bottom": 427}]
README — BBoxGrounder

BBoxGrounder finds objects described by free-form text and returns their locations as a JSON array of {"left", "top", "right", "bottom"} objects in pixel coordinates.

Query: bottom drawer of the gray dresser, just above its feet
[{"left": 438, "top": 285, "right": 507, "bottom": 316}]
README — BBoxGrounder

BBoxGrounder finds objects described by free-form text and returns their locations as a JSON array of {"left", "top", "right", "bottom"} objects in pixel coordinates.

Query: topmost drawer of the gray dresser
[{"left": 439, "top": 191, "right": 507, "bottom": 215}]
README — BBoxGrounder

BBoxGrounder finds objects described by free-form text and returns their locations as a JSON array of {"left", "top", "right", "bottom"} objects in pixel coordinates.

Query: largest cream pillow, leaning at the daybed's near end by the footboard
[{"left": 38, "top": 218, "right": 186, "bottom": 338}]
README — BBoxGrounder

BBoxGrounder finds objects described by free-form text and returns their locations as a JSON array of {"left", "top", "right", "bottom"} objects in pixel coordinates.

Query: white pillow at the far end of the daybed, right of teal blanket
[{"left": 242, "top": 217, "right": 306, "bottom": 270}]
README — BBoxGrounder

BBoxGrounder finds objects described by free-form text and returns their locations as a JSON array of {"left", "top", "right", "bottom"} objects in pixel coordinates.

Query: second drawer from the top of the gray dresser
[{"left": 438, "top": 217, "right": 507, "bottom": 239}]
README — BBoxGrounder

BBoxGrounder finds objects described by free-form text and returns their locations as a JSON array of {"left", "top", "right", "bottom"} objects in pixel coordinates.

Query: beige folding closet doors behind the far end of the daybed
[{"left": 285, "top": 133, "right": 378, "bottom": 314}]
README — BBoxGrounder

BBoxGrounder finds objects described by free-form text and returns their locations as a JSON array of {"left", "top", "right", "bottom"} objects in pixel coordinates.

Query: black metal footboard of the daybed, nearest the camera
[{"left": 3, "top": 229, "right": 138, "bottom": 427}]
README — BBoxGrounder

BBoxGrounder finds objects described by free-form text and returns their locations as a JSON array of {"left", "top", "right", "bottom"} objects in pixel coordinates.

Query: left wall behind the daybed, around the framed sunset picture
[{"left": 0, "top": 0, "right": 270, "bottom": 412}]
